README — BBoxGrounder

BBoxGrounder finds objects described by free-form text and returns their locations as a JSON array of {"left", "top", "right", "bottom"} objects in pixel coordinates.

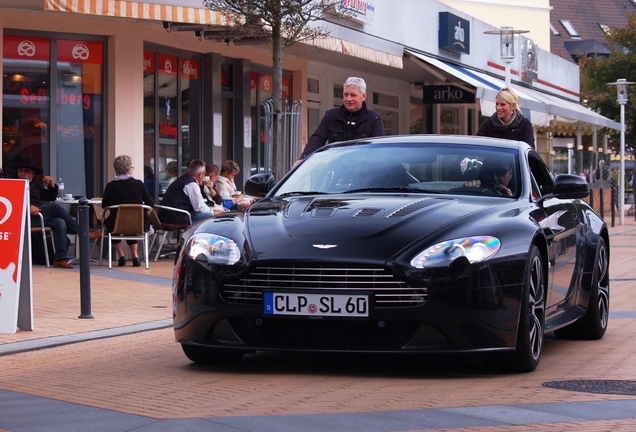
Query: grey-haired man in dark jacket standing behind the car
[{"left": 296, "top": 77, "right": 384, "bottom": 164}]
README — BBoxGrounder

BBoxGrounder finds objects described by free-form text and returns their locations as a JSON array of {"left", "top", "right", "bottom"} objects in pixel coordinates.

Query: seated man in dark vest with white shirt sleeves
[{"left": 159, "top": 159, "right": 213, "bottom": 224}]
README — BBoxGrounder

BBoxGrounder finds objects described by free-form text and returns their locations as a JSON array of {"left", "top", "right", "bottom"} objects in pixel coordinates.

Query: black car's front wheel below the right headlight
[{"left": 503, "top": 245, "right": 546, "bottom": 372}]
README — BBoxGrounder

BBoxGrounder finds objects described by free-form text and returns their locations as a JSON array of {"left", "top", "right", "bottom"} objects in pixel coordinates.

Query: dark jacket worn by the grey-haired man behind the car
[{"left": 300, "top": 102, "right": 384, "bottom": 159}]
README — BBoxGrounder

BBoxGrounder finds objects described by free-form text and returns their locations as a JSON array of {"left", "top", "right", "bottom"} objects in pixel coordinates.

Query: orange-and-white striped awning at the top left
[{"left": 44, "top": 0, "right": 226, "bottom": 25}]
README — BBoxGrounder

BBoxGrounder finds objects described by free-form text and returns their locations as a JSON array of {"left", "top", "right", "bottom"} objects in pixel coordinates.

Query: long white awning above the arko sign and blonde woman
[{"left": 408, "top": 51, "right": 621, "bottom": 132}]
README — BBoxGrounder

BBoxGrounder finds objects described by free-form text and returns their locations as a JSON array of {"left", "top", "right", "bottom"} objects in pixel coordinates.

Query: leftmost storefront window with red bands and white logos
[{"left": 2, "top": 35, "right": 104, "bottom": 197}]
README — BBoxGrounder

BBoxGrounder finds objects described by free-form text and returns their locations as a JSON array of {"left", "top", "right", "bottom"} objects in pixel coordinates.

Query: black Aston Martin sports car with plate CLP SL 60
[{"left": 173, "top": 135, "right": 609, "bottom": 371}]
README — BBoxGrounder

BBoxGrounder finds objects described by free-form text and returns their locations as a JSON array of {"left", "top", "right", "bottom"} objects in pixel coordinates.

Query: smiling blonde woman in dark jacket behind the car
[{"left": 477, "top": 87, "right": 534, "bottom": 148}]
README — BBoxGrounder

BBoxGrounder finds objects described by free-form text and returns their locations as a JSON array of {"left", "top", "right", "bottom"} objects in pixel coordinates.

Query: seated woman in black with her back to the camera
[{"left": 102, "top": 155, "right": 155, "bottom": 267}]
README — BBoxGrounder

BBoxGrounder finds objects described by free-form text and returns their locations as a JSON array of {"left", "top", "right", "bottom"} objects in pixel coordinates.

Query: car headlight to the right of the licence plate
[{"left": 411, "top": 236, "right": 501, "bottom": 268}]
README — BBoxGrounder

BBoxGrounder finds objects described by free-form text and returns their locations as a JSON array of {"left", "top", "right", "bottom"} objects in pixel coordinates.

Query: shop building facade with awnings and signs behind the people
[{"left": 0, "top": 0, "right": 616, "bottom": 197}]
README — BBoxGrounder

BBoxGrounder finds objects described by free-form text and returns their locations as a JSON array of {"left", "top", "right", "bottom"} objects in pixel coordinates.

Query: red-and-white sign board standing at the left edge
[{"left": 0, "top": 179, "right": 30, "bottom": 333}]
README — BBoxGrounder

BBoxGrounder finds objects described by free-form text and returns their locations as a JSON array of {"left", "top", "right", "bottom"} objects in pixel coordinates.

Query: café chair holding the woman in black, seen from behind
[{"left": 99, "top": 204, "right": 152, "bottom": 270}]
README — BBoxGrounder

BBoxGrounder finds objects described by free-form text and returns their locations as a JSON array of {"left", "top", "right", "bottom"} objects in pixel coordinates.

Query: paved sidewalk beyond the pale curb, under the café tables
[{"left": 0, "top": 213, "right": 636, "bottom": 356}]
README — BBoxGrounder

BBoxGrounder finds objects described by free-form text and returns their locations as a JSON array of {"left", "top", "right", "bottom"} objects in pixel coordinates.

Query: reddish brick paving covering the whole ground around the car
[{"left": 0, "top": 218, "right": 636, "bottom": 432}]
